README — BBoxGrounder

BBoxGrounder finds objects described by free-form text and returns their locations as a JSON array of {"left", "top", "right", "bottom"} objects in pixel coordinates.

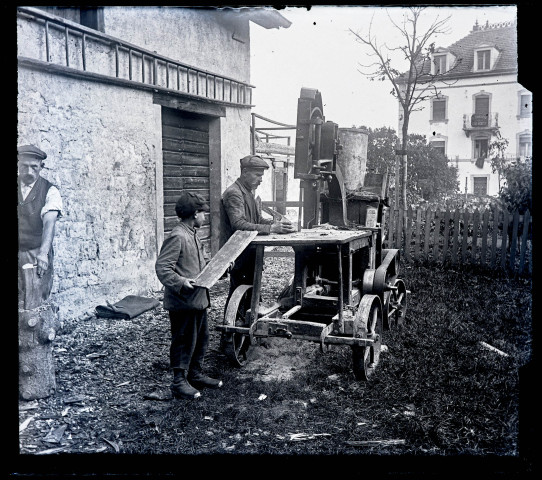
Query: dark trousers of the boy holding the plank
[{"left": 169, "top": 309, "right": 209, "bottom": 371}]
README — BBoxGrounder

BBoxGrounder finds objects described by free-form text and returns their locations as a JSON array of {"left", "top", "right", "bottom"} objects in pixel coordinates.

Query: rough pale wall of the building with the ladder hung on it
[{"left": 17, "top": 7, "right": 254, "bottom": 317}]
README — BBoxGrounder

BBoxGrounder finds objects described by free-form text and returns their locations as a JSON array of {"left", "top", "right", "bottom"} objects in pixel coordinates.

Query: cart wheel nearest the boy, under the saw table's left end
[{"left": 221, "top": 285, "right": 252, "bottom": 367}]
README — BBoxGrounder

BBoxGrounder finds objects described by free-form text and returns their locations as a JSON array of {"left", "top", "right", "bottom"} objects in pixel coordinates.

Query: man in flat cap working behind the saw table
[{"left": 222, "top": 155, "right": 295, "bottom": 307}]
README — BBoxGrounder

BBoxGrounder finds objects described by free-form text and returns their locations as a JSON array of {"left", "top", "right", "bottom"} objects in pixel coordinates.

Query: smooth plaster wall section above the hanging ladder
[{"left": 104, "top": 7, "right": 250, "bottom": 82}]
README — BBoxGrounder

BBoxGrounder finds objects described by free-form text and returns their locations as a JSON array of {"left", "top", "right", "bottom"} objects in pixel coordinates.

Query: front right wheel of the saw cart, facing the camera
[{"left": 352, "top": 295, "right": 382, "bottom": 380}]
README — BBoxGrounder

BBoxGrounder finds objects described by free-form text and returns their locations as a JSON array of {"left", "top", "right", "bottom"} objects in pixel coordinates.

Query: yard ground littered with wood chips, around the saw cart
[{"left": 14, "top": 258, "right": 531, "bottom": 480}]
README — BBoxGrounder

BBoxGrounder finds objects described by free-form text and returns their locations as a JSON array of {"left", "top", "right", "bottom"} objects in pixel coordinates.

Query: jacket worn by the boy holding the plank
[{"left": 155, "top": 222, "right": 210, "bottom": 310}]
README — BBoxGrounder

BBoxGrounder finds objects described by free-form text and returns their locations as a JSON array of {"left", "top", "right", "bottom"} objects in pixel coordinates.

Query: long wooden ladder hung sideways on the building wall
[{"left": 17, "top": 7, "right": 254, "bottom": 107}]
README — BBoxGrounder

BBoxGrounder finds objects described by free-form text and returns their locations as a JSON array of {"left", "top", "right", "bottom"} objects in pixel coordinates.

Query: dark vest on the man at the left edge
[{"left": 17, "top": 177, "right": 52, "bottom": 251}]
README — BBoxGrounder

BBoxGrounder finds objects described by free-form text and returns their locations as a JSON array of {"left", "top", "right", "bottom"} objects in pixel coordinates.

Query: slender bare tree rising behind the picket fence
[{"left": 350, "top": 7, "right": 461, "bottom": 214}]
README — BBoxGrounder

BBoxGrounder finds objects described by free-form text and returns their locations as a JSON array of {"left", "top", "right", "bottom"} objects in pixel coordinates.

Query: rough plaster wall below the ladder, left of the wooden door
[{"left": 18, "top": 68, "right": 161, "bottom": 316}]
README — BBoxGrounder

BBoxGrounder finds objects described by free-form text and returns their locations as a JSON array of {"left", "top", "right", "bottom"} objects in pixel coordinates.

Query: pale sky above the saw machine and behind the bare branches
[{"left": 250, "top": 5, "right": 517, "bottom": 130}]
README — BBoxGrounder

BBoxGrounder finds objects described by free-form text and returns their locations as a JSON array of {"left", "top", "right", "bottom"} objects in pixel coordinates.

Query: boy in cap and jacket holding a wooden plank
[{"left": 155, "top": 192, "right": 222, "bottom": 399}]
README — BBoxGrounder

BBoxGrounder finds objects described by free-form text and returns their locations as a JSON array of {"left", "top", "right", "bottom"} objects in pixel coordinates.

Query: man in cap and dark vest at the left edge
[{"left": 17, "top": 145, "right": 62, "bottom": 308}]
